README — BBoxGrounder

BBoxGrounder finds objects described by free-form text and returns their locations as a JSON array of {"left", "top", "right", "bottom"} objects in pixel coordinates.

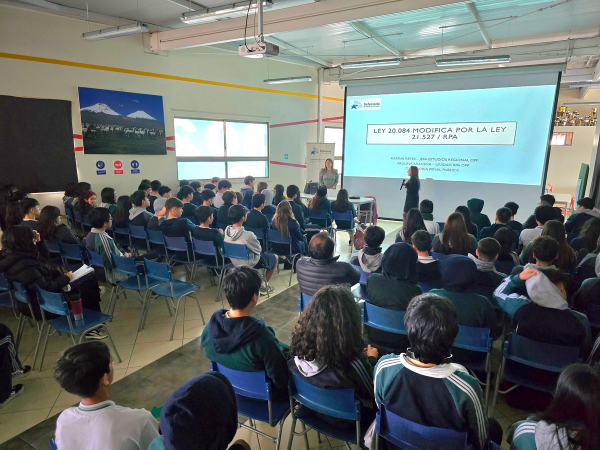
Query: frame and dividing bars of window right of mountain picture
[{"left": 173, "top": 116, "right": 271, "bottom": 180}]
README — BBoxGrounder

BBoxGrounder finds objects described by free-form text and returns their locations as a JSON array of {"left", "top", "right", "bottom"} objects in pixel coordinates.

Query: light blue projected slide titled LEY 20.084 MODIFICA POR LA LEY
[{"left": 344, "top": 85, "right": 556, "bottom": 186}]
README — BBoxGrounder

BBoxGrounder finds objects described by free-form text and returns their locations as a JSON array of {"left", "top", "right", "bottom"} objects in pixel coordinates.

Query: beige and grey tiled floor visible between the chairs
[{"left": 0, "top": 221, "right": 526, "bottom": 450}]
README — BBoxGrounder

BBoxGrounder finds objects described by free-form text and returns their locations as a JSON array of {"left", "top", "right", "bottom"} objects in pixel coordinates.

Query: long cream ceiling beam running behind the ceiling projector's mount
[{"left": 151, "top": 0, "right": 462, "bottom": 51}]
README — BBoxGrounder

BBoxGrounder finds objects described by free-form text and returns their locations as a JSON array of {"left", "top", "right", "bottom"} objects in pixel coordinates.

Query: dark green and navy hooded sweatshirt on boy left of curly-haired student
[{"left": 201, "top": 309, "right": 289, "bottom": 395}]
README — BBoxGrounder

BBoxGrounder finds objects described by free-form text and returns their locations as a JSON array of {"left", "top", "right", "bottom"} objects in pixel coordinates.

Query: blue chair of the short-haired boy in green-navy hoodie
[{"left": 210, "top": 361, "right": 290, "bottom": 450}]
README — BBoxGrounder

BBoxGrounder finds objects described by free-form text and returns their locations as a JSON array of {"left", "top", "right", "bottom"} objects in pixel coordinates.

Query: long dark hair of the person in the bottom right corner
[{"left": 536, "top": 364, "right": 600, "bottom": 450}]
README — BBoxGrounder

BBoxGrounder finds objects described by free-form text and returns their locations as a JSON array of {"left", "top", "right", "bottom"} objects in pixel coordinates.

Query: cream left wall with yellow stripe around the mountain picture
[{"left": 0, "top": 5, "right": 343, "bottom": 206}]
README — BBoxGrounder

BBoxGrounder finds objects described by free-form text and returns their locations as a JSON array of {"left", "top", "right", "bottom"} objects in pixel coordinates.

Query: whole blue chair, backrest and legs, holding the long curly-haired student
[{"left": 288, "top": 373, "right": 366, "bottom": 450}]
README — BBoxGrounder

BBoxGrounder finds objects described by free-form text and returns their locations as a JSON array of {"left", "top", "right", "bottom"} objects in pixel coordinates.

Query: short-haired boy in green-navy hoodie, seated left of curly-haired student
[{"left": 201, "top": 268, "right": 289, "bottom": 399}]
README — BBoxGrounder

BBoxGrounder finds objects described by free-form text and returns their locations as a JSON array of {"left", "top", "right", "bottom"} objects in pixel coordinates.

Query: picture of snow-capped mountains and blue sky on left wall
[{"left": 79, "top": 87, "right": 167, "bottom": 155}]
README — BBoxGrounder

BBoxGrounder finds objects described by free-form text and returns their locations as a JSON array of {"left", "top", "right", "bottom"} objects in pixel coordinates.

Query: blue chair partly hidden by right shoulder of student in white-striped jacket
[{"left": 452, "top": 325, "right": 492, "bottom": 407}]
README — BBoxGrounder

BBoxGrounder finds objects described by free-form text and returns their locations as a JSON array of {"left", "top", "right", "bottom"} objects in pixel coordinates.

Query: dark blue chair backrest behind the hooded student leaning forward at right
[{"left": 503, "top": 333, "right": 580, "bottom": 373}]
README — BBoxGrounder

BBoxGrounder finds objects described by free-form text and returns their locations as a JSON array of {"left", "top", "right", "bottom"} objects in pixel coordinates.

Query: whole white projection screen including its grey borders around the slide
[{"left": 341, "top": 65, "right": 564, "bottom": 223}]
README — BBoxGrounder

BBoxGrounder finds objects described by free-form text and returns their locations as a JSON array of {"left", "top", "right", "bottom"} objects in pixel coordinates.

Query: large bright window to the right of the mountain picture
[{"left": 175, "top": 117, "right": 269, "bottom": 180}]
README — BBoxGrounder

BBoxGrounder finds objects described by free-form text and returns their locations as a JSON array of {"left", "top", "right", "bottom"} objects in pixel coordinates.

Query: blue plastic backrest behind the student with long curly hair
[{"left": 289, "top": 373, "right": 360, "bottom": 420}]
